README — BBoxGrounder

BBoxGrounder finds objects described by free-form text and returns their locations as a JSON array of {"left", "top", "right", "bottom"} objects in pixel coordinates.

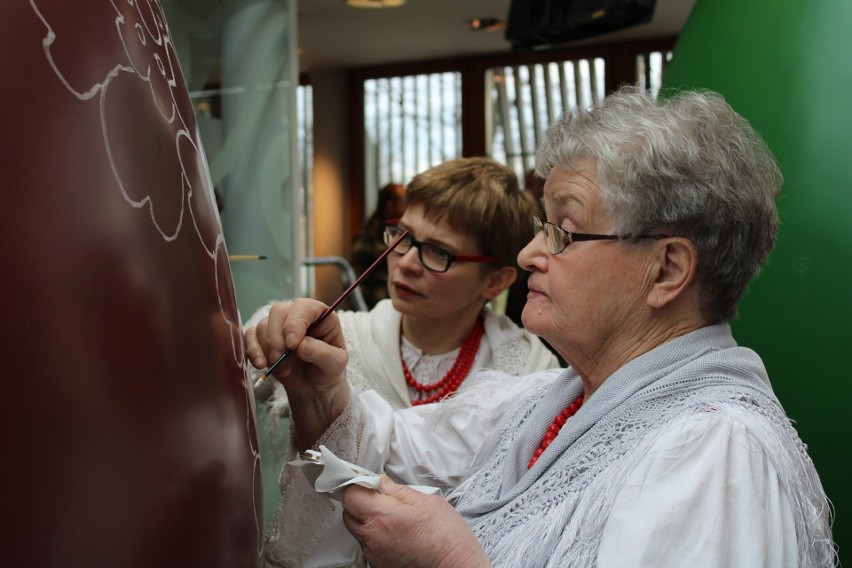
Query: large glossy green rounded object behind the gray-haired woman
[{"left": 663, "top": 0, "right": 852, "bottom": 562}]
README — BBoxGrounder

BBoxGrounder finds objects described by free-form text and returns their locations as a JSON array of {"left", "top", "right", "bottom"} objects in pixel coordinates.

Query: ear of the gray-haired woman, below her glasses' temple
[{"left": 647, "top": 237, "right": 698, "bottom": 308}]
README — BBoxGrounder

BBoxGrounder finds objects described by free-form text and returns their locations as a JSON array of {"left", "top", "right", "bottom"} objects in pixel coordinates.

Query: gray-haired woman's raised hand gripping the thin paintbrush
[{"left": 245, "top": 299, "right": 349, "bottom": 451}]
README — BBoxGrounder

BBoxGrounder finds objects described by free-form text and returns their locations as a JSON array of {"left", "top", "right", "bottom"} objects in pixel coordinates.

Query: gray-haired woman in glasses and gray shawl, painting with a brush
[{"left": 248, "top": 85, "right": 837, "bottom": 568}]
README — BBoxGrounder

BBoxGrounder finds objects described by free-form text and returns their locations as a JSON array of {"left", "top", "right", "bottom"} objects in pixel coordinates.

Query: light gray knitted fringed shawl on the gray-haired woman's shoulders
[{"left": 449, "top": 324, "right": 836, "bottom": 567}]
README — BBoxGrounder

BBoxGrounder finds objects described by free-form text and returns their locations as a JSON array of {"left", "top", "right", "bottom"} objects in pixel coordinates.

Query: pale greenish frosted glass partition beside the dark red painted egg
[{"left": 162, "top": 0, "right": 300, "bottom": 525}]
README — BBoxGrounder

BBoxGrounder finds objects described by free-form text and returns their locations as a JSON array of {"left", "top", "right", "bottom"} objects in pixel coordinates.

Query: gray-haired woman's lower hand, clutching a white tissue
[{"left": 343, "top": 477, "right": 491, "bottom": 568}]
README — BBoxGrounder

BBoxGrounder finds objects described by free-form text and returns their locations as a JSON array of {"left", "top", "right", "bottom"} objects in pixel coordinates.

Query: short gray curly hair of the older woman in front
[{"left": 536, "top": 87, "right": 783, "bottom": 321}]
